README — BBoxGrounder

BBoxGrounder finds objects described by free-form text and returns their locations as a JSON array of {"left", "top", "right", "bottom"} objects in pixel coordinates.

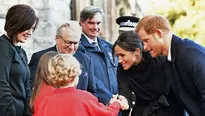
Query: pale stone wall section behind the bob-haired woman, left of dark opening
[{"left": 0, "top": 0, "right": 71, "bottom": 59}]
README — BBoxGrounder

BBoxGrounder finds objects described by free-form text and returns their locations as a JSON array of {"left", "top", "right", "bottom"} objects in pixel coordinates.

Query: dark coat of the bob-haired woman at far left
[{"left": 0, "top": 35, "right": 31, "bottom": 116}]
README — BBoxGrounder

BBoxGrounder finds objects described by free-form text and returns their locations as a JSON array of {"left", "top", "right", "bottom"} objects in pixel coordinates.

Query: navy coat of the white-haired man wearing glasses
[{"left": 29, "top": 46, "right": 97, "bottom": 96}]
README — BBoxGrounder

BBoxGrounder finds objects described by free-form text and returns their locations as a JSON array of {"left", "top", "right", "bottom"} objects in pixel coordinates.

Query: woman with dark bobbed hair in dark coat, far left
[{"left": 0, "top": 4, "right": 39, "bottom": 116}]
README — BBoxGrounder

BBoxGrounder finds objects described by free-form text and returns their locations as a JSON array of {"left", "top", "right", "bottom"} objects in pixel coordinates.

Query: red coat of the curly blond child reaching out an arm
[{"left": 36, "top": 87, "right": 121, "bottom": 116}]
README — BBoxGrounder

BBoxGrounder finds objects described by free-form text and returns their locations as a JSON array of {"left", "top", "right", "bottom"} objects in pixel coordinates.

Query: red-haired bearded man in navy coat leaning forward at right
[{"left": 136, "top": 15, "right": 205, "bottom": 116}]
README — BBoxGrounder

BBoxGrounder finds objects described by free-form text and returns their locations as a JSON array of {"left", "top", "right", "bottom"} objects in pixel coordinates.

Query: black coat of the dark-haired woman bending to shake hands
[{"left": 117, "top": 52, "right": 184, "bottom": 116}]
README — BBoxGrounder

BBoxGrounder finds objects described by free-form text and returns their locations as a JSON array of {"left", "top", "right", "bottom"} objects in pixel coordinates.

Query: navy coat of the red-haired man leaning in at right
[{"left": 166, "top": 35, "right": 205, "bottom": 116}]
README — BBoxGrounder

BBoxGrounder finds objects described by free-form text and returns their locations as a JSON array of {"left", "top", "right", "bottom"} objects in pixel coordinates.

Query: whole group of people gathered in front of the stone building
[{"left": 0, "top": 4, "right": 205, "bottom": 116}]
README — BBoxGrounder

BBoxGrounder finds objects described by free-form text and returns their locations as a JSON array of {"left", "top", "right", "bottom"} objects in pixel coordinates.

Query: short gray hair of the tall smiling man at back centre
[{"left": 80, "top": 6, "right": 104, "bottom": 21}]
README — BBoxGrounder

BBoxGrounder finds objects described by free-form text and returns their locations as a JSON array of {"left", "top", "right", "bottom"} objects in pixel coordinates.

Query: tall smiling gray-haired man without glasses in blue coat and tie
[{"left": 78, "top": 6, "right": 118, "bottom": 105}]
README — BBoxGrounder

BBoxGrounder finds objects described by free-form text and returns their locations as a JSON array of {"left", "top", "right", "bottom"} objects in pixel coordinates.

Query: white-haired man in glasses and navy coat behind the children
[{"left": 29, "top": 21, "right": 98, "bottom": 96}]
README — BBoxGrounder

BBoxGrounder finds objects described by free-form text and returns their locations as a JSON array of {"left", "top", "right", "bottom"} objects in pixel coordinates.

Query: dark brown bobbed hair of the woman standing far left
[{"left": 4, "top": 4, "right": 39, "bottom": 42}]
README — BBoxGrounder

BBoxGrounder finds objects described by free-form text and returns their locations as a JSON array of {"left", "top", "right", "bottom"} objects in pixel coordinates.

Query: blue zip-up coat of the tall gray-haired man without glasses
[{"left": 78, "top": 34, "right": 118, "bottom": 105}]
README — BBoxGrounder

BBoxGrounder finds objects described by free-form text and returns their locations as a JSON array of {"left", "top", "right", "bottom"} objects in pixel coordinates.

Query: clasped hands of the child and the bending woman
[{"left": 109, "top": 94, "right": 129, "bottom": 110}]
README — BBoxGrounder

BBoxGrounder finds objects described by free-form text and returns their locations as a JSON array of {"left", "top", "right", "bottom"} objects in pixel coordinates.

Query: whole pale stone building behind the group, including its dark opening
[{"left": 0, "top": 0, "right": 142, "bottom": 59}]
